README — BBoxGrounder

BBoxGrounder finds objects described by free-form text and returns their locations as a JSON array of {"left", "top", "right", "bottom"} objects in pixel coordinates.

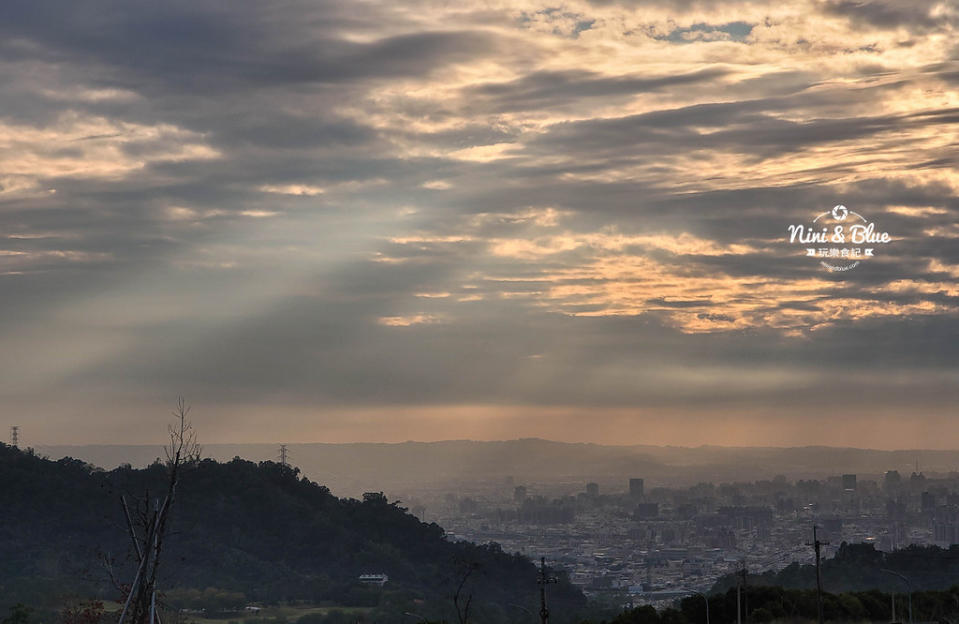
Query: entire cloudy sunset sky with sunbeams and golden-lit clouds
[{"left": 0, "top": 0, "right": 959, "bottom": 448}]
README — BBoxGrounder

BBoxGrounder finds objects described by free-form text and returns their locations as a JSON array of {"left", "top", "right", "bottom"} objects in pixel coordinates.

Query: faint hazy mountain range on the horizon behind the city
[{"left": 30, "top": 439, "right": 959, "bottom": 496}]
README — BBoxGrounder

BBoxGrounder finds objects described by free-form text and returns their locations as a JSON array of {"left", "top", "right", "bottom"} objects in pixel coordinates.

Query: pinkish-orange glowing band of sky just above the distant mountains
[{"left": 15, "top": 402, "right": 959, "bottom": 450}]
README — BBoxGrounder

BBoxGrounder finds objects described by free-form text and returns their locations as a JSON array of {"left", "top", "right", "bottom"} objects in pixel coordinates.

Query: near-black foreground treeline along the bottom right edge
[{"left": 584, "top": 585, "right": 959, "bottom": 624}]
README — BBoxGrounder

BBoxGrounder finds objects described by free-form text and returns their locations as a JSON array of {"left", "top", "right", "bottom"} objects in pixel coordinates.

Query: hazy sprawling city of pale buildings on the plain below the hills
[{"left": 406, "top": 471, "right": 959, "bottom": 603}]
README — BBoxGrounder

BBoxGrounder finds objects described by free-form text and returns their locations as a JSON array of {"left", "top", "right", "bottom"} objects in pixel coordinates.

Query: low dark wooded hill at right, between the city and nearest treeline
[{"left": 713, "top": 542, "right": 959, "bottom": 593}]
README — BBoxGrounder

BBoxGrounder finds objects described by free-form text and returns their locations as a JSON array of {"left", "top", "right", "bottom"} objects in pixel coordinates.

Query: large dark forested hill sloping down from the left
[{"left": 0, "top": 444, "right": 585, "bottom": 621}]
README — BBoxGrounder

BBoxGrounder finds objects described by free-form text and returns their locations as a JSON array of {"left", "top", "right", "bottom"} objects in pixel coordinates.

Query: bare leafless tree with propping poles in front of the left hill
[{"left": 118, "top": 397, "right": 202, "bottom": 624}]
